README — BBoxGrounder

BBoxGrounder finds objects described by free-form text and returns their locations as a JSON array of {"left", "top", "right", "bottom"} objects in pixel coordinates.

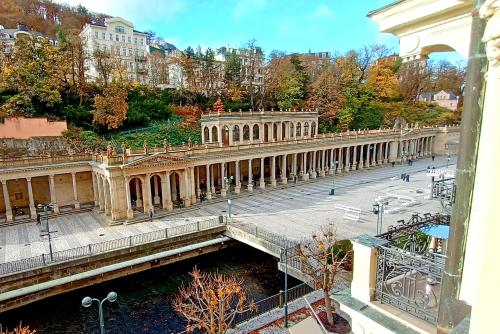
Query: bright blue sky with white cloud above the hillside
[{"left": 56, "top": 0, "right": 460, "bottom": 62}]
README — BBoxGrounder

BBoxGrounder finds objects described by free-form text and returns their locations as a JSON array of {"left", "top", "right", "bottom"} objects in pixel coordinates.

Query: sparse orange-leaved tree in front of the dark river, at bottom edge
[{"left": 173, "top": 267, "right": 257, "bottom": 334}]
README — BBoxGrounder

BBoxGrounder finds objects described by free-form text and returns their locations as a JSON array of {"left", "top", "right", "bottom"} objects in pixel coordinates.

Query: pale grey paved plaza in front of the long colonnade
[{"left": 0, "top": 157, "right": 455, "bottom": 263}]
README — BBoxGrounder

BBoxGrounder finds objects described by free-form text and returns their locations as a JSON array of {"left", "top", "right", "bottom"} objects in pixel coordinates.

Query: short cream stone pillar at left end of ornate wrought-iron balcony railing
[{"left": 351, "top": 234, "right": 387, "bottom": 304}]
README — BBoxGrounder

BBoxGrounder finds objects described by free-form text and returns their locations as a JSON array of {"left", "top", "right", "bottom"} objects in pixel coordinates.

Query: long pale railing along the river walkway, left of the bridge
[{"left": 0, "top": 218, "right": 227, "bottom": 277}]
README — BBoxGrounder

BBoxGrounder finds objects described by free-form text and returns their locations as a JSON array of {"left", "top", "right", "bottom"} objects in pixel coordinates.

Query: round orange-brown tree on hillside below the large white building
[{"left": 93, "top": 85, "right": 128, "bottom": 130}]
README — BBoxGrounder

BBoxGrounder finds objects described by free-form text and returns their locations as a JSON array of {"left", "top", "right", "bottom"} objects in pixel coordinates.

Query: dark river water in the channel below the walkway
[{"left": 0, "top": 244, "right": 300, "bottom": 334}]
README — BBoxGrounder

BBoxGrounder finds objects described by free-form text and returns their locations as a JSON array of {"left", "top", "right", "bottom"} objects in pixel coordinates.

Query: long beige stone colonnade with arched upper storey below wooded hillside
[{"left": 0, "top": 111, "right": 458, "bottom": 223}]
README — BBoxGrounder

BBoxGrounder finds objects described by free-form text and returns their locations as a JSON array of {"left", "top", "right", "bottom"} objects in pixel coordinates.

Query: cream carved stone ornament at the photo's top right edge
[{"left": 479, "top": 0, "right": 500, "bottom": 67}]
